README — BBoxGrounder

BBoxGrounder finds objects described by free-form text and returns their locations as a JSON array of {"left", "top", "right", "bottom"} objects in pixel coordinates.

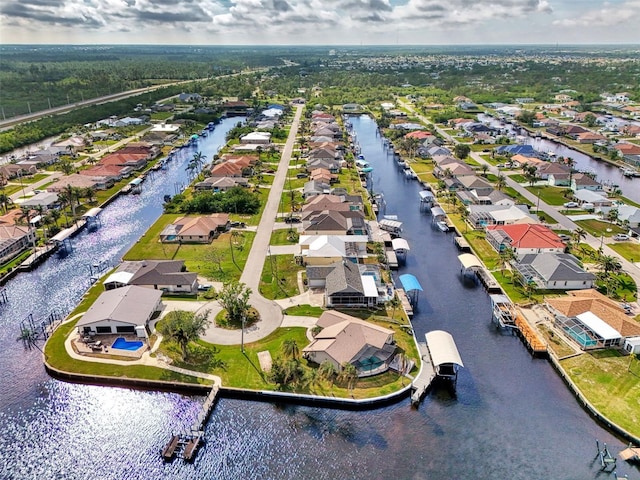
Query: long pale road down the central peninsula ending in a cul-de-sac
[{"left": 202, "top": 105, "right": 303, "bottom": 345}]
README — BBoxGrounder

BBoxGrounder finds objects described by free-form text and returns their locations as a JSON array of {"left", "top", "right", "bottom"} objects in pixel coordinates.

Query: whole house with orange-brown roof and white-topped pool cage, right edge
[{"left": 546, "top": 289, "right": 640, "bottom": 350}]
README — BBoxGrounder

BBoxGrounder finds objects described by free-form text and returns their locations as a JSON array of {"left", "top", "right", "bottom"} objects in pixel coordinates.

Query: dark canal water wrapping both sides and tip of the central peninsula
[{"left": 0, "top": 117, "right": 638, "bottom": 480}]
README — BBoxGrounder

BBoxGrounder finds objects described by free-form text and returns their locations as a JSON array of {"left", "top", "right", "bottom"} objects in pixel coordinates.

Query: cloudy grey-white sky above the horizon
[{"left": 0, "top": 0, "right": 640, "bottom": 45}]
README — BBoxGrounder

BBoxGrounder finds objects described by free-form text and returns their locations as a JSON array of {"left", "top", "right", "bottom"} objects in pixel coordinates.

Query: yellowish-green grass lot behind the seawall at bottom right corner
[{"left": 560, "top": 350, "right": 640, "bottom": 436}]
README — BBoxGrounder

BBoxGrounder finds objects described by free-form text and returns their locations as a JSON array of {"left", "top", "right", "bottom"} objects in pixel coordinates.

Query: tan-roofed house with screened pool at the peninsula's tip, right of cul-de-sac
[{"left": 302, "top": 310, "right": 396, "bottom": 377}]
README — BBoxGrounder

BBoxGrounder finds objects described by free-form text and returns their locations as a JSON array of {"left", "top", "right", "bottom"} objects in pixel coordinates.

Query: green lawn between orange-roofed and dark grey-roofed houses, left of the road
[{"left": 123, "top": 214, "right": 255, "bottom": 282}]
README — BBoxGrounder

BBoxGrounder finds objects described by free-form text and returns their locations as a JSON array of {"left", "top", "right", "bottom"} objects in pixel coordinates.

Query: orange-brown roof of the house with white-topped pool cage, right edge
[{"left": 547, "top": 289, "right": 640, "bottom": 337}]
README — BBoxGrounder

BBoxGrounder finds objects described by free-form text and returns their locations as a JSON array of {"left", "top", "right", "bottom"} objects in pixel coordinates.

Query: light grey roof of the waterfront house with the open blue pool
[{"left": 77, "top": 286, "right": 162, "bottom": 327}]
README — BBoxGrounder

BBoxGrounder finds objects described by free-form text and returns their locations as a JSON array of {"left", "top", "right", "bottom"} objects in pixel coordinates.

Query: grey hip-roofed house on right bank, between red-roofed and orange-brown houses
[{"left": 511, "top": 253, "right": 596, "bottom": 290}]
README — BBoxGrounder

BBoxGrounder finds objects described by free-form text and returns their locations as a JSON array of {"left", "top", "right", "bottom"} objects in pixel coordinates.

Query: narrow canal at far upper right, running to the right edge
[{"left": 478, "top": 114, "right": 640, "bottom": 202}]
